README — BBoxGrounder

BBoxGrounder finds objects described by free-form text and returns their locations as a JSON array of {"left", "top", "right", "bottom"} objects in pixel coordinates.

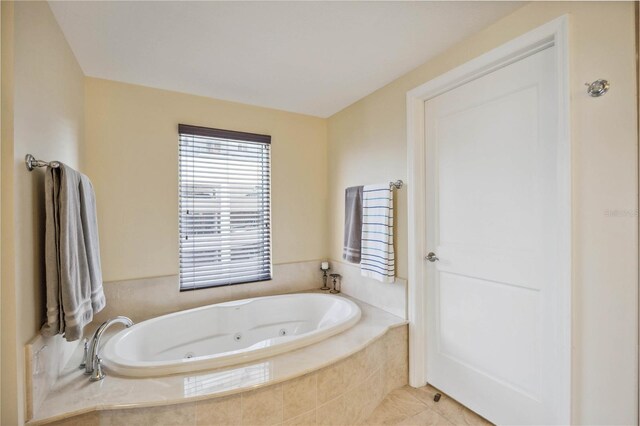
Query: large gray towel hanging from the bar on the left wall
[{"left": 41, "top": 163, "right": 106, "bottom": 341}]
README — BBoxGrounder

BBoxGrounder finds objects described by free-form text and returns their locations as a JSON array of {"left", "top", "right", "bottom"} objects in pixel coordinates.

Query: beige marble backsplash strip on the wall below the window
[{"left": 94, "top": 260, "right": 322, "bottom": 324}]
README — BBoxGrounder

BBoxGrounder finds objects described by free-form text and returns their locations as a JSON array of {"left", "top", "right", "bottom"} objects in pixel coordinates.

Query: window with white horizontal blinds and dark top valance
[{"left": 178, "top": 124, "right": 271, "bottom": 290}]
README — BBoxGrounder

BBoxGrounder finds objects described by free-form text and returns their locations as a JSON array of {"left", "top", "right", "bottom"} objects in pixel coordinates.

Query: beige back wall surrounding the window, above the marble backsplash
[{"left": 84, "top": 78, "right": 327, "bottom": 281}]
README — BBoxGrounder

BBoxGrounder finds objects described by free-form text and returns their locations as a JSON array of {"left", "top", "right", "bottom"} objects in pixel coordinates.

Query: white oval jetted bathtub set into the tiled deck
[{"left": 101, "top": 293, "right": 360, "bottom": 377}]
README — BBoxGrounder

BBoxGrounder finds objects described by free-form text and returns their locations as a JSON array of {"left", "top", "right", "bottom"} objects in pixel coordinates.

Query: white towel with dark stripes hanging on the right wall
[{"left": 360, "top": 183, "right": 395, "bottom": 283}]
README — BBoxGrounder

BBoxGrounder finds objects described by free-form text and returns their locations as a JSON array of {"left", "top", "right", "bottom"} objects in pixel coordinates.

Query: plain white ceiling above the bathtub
[{"left": 49, "top": 1, "right": 522, "bottom": 117}]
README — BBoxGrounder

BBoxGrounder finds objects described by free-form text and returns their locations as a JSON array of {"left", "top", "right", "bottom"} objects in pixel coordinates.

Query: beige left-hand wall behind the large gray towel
[{"left": 2, "top": 2, "right": 84, "bottom": 425}]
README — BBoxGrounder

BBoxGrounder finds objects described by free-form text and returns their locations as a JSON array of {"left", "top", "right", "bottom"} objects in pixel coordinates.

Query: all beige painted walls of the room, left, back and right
[{"left": 0, "top": 2, "right": 638, "bottom": 425}]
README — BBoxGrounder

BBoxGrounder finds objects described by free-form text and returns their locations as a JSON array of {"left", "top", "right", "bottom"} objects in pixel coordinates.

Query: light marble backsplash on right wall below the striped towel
[{"left": 329, "top": 260, "right": 407, "bottom": 319}]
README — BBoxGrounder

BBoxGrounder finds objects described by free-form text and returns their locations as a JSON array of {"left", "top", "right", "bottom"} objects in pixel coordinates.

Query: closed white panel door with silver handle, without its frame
[{"left": 425, "top": 47, "right": 570, "bottom": 424}]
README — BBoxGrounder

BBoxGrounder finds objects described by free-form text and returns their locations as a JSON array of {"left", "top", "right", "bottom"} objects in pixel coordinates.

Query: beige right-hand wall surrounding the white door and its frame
[{"left": 329, "top": 2, "right": 638, "bottom": 424}]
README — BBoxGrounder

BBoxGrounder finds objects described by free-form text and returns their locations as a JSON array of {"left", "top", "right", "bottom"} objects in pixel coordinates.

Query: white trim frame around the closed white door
[{"left": 407, "top": 15, "right": 572, "bottom": 424}]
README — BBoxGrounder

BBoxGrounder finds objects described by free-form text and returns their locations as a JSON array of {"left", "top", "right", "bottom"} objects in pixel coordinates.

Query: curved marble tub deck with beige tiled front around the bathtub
[{"left": 29, "top": 296, "right": 408, "bottom": 424}]
